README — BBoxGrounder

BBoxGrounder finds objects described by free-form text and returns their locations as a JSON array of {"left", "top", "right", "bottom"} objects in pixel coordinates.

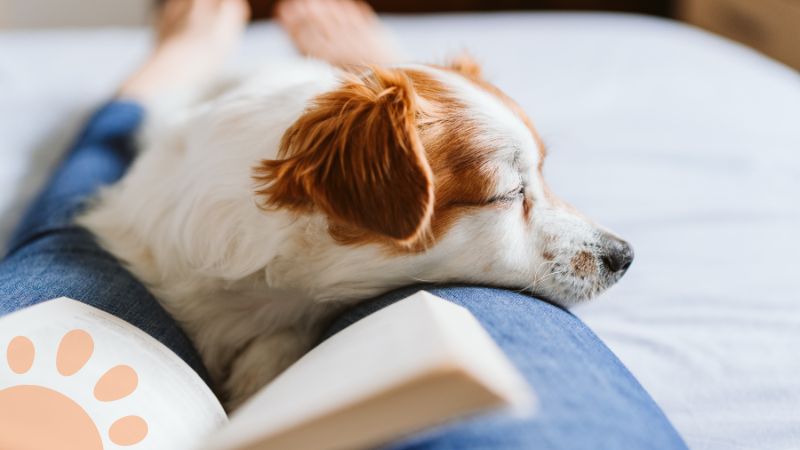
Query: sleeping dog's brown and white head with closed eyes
[{"left": 255, "top": 58, "right": 633, "bottom": 306}]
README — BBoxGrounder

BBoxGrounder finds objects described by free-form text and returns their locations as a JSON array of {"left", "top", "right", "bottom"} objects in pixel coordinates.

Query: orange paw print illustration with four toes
[{"left": 0, "top": 330, "right": 147, "bottom": 450}]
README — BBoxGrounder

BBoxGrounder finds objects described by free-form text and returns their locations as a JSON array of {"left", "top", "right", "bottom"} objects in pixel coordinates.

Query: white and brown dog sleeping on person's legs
[{"left": 78, "top": 58, "right": 633, "bottom": 409}]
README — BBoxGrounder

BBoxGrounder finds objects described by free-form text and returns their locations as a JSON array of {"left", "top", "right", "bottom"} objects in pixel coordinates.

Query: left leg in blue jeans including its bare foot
[{"left": 0, "top": 0, "right": 247, "bottom": 375}]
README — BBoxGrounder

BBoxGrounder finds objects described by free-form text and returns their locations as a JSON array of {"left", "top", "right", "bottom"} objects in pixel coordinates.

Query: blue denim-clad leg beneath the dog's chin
[{"left": 327, "top": 286, "right": 686, "bottom": 450}]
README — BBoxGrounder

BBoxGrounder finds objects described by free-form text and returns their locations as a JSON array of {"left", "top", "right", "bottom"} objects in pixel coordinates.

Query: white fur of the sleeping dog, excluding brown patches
[{"left": 79, "top": 62, "right": 632, "bottom": 407}]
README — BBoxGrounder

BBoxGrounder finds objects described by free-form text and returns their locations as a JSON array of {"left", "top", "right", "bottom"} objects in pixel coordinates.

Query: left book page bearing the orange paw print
[{"left": 0, "top": 298, "right": 227, "bottom": 450}]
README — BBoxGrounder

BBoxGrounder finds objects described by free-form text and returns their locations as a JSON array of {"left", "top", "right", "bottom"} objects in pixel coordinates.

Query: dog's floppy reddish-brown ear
[{"left": 254, "top": 68, "right": 433, "bottom": 244}]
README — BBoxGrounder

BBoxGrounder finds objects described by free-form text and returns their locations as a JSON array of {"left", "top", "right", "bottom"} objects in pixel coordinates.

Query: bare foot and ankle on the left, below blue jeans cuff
[{"left": 119, "top": 0, "right": 250, "bottom": 102}]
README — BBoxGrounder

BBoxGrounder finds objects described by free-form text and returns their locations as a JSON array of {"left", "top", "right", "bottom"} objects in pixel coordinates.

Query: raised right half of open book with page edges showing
[{"left": 202, "top": 291, "right": 535, "bottom": 450}]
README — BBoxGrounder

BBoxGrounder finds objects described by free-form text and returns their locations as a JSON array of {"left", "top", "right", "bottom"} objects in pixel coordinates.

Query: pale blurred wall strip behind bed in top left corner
[{"left": 0, "top": 0, "right": 150, "bottom": 28}]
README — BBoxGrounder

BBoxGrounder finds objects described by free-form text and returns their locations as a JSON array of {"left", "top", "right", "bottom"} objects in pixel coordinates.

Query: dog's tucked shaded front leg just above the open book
[{"left": 223, "top": 329, "right": 314, "bottom": 411}]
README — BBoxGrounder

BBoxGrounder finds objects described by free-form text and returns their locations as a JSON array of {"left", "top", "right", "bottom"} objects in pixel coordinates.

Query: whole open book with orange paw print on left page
[{"left": 0, "top": 292, "right": 533, "bottom": 450}]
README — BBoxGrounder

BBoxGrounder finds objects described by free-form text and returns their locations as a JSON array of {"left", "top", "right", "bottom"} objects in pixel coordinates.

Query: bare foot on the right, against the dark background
[{"left": 275, "top": 0, "right": 400, "bottom": 66}]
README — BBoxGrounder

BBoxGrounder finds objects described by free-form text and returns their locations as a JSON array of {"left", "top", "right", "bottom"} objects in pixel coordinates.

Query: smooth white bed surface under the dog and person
[{"left": 0, "top": 13, "right": 800, "bottom": 449}]
